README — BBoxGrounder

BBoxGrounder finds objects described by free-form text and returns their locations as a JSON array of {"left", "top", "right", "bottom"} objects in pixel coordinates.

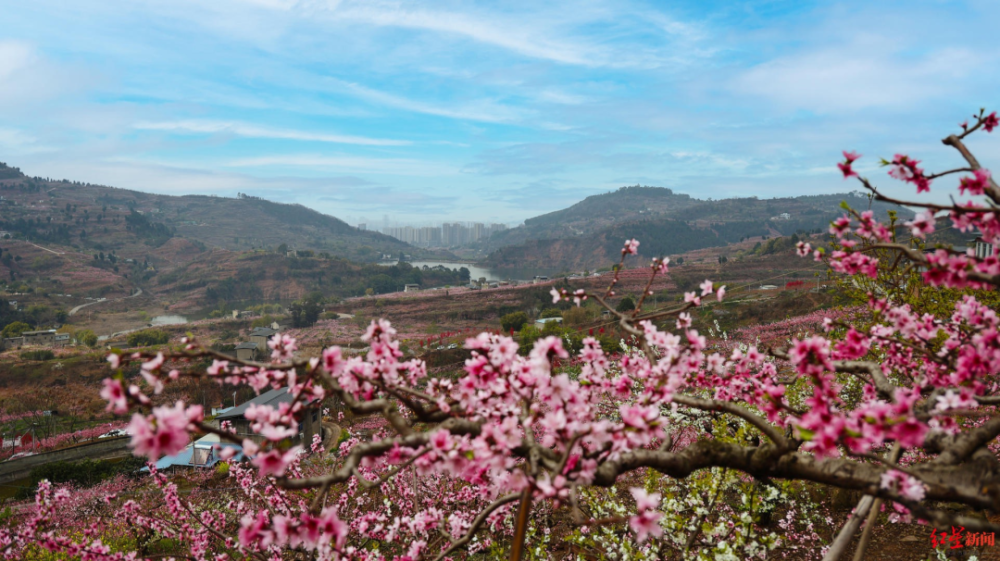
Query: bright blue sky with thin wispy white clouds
[{"left": 0, "top": 0, "right": 1000, "bottom": 227}]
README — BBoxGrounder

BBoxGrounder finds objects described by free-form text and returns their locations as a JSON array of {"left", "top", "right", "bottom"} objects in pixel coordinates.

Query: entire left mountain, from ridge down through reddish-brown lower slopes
[{"left": 0, "top": 164, "right": 469, "bottom": 316}]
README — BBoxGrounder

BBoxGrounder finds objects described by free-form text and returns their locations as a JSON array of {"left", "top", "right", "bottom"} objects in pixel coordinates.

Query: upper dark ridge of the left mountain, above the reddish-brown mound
[{"left": 0, "top": 165, "right": 446, "bottom": 261}]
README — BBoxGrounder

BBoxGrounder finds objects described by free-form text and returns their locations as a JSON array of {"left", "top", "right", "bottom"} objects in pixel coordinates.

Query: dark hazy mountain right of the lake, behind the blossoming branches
[{"left": 485, "top": 187, "right": 913, "bottom": 270}]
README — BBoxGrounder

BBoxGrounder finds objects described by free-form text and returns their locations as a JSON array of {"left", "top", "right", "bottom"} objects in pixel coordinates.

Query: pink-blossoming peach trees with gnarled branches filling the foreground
[{"left": 0, "top": 112, "right": 1000, "bottom": 561}]
